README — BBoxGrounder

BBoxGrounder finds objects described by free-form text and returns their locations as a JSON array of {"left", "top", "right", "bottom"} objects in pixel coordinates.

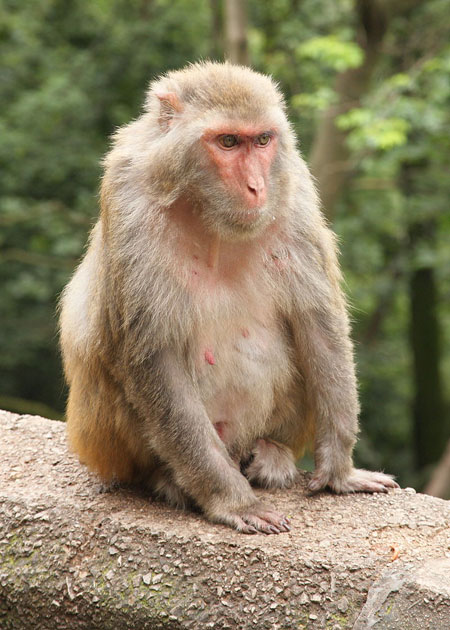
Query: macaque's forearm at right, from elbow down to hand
[{"left": 293, "top": 302, "right": 398, "bottom": 493}]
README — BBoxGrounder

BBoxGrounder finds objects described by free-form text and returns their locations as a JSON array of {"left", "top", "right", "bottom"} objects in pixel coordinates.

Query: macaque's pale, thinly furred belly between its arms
[{"left": 196, "top": 324, "right": 293, "bottom": 451}]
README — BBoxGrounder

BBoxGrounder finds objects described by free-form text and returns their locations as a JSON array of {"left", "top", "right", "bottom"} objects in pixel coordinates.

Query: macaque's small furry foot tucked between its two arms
[{"left": 245, "top": 439, "right": 297, "bottom": 488}]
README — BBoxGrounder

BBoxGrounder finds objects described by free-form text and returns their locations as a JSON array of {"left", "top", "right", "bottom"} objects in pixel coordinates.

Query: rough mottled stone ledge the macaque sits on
[{"left": 0, "top": 412, "right": 450, "bottom": 630}]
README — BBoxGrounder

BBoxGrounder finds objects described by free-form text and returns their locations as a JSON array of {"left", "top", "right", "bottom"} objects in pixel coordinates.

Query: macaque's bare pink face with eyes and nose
[{"left": 203, "top": 126, "right": 277, "bottom": 218}]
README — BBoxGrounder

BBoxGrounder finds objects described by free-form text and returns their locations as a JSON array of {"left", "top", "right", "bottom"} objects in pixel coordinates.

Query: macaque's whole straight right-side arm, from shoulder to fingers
[{"left": 289, "top": 225, "right": 397, "bottom": 492}]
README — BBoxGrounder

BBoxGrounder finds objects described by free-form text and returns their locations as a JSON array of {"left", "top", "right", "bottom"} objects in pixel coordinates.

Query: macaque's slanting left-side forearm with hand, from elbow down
[{"left": 123, "top": 350, "right": 290, "bottom": 534}]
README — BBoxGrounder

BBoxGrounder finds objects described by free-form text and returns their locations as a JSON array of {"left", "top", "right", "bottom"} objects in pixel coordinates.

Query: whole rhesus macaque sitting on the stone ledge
[{"left": 61, "top": 63, "right": 397, "bottom": 534}]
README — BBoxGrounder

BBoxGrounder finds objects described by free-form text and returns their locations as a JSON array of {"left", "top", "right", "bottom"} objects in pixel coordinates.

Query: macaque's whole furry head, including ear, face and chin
[{"left": 144, "top": 62, "right": 295, "bottom": 239}]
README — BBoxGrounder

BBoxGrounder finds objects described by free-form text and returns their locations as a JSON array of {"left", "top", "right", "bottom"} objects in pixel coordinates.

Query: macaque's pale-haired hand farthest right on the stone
[{"left": 308, "top": 468, "right": 400, "bottom": 494}]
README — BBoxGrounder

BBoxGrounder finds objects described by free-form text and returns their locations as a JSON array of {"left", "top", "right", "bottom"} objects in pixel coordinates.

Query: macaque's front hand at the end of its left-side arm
[{"left": 211, "top": 501, "right": 291, "bottom": 534}]
